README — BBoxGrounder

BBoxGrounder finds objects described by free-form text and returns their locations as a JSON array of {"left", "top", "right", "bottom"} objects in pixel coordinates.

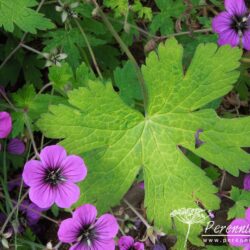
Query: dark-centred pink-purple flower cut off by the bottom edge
[{"left": 58, "top": 204, "right": 119, "bottom": 250}]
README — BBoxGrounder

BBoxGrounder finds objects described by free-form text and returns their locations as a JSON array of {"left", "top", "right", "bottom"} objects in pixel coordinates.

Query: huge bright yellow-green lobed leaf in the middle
[{"left": 38, "top": 39, "right": 250, "bottom": 249}]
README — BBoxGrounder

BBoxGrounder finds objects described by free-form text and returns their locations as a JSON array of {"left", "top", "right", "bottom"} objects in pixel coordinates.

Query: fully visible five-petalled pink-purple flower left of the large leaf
[{"left": 23, "top": 145, "right": 87, "bottom": 208}]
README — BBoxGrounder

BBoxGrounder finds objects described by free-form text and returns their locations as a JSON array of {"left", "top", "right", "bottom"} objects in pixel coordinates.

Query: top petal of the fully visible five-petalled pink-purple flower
[{"left": 40, "top": 145, "right": 67, "bottom": 167}]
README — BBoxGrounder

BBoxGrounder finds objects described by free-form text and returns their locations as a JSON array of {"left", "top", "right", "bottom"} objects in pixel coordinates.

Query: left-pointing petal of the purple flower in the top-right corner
[{"left": 212, "top": 11, "right": 233, "bottom": 33}]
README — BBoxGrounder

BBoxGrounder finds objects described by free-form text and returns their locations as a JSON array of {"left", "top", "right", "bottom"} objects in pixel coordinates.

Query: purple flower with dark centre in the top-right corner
[{"left": 212, "top": 0, "right": 250, "bottom": 50}]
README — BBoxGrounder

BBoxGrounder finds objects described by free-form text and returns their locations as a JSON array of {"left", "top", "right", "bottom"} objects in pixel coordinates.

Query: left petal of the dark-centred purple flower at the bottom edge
[{"left": 57, "top": 218, "right": 81, "bottom": 243}]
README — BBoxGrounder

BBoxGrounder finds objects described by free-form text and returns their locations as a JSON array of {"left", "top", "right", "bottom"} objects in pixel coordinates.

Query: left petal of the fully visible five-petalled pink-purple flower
[{"left": 22, "top": 160, "right": 45, "bottom": 187}]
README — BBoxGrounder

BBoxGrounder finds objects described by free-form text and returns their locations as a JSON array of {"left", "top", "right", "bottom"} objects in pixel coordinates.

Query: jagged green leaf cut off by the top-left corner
[{"left": 0, "top": 0, "right": 54, "bottom": 34}]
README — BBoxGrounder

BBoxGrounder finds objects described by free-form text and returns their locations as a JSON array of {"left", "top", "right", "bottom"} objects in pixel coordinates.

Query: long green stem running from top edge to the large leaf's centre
[{"left": 91, "top": 0, "right": 148, "bottom": 115}]
